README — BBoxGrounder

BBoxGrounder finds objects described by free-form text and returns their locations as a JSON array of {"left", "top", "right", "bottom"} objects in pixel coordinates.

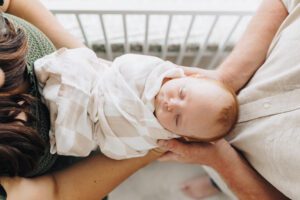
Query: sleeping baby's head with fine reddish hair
[{"left": 155, "top": 76, "right": 238, "bottom": 141}]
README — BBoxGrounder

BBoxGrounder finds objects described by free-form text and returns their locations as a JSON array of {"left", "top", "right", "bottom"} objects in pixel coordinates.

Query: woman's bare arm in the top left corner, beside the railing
[{"left": 0, "top": 0, "right": 84, "bottom": 48}]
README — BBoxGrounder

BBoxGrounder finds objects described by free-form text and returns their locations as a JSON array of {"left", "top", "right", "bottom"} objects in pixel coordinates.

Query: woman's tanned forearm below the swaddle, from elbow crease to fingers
[{"left": 53, "top": 152, "right": 160, "bottom": 200}]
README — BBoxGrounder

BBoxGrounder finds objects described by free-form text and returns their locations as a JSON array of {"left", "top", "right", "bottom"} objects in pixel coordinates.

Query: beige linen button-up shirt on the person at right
[{"left": 209, "top": 0, "right": 300, "bottom": 199}]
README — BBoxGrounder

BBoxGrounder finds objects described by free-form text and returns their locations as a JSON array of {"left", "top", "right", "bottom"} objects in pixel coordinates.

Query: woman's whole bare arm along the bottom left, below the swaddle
[{"left": 0, "top": 151, "right": 161, "bottom": 200}]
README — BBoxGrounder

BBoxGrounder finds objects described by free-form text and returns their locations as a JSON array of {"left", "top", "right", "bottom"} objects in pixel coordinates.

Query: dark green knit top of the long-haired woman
[{"left": 4, "top": 14, "right": 57, "bottom": 176}]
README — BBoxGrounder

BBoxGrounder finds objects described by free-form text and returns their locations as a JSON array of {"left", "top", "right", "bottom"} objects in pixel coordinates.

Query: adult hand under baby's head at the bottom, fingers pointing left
[{"left": 158, "top": 139, "right": 235, "bottom": 168}]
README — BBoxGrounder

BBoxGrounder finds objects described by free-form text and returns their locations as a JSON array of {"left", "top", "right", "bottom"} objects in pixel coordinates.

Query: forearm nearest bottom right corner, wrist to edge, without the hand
[{"left": 212, "top": 148, "right": 288, "bottom": 200}]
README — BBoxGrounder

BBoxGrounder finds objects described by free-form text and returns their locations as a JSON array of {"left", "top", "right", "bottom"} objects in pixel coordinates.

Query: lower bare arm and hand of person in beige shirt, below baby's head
[{"left": 159, "top": 139, "right": 288, "bottom": 200}]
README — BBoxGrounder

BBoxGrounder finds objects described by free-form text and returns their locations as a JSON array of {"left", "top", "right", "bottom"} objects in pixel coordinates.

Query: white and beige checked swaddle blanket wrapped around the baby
[{"left": 35, "top": 48, "right": 184, "bottom": 159}]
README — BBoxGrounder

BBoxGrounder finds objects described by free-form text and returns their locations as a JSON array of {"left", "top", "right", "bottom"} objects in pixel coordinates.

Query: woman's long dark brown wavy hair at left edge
[{"left": 0, "top": 13, "right": 45, "bottom": 176}]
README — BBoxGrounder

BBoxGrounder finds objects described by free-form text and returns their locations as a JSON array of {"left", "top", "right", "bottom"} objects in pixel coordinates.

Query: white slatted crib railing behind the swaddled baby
[{"left": 51, "top": 9, "right": 253, "bottom": 68}]
